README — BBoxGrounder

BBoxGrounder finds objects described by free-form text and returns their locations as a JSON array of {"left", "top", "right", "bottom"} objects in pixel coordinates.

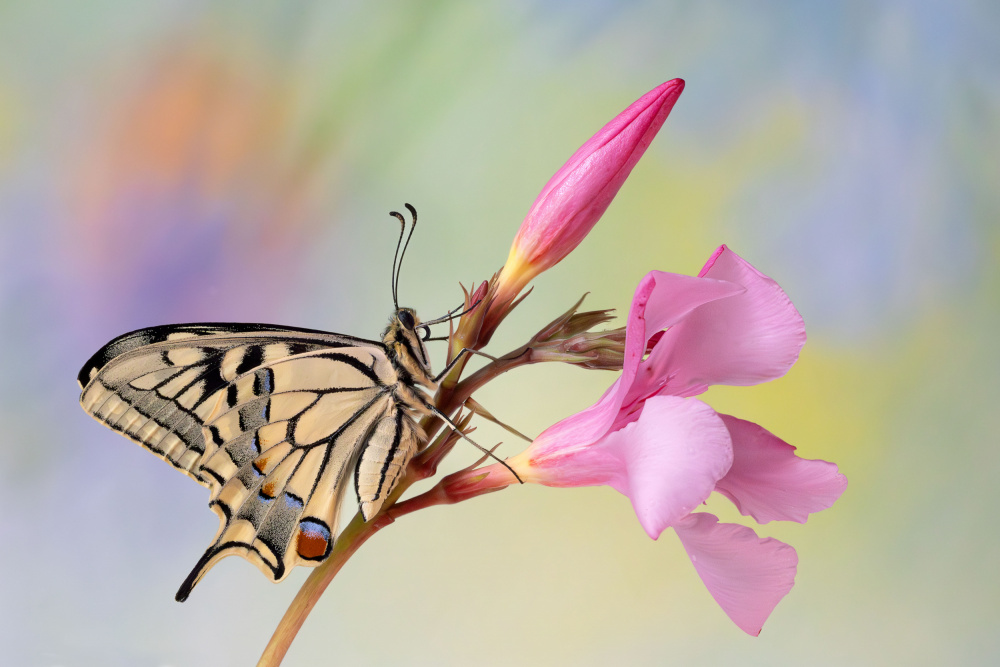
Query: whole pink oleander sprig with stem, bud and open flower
[{"left": 262, "top": 79, "right": 847, "bottom": 664}]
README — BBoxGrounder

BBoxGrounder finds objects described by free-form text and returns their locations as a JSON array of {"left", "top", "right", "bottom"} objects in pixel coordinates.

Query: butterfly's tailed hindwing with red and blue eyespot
[{"left": 180, "top": 348, "right": 415, "bottom": 597}]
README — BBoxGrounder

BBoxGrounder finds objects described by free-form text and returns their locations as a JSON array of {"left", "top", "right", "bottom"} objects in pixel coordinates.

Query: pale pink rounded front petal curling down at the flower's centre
[{"left": 588, "top": 396, "right": 732, "bottom": 540}]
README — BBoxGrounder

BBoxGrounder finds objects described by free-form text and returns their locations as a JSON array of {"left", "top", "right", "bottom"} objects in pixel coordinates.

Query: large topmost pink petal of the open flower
[{"left": 642, "top": 246, "right": 806, "bottom": 396}]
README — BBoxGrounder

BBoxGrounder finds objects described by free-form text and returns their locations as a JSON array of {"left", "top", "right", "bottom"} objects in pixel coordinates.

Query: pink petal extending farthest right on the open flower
[{"left": 716, "top": 415, "right": 847, "bottom": 523}]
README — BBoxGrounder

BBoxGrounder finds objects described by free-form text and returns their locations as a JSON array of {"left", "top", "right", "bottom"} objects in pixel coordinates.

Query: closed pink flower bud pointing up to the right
[{"left": 497, "top": 79, "right": 684, "bottom": 303}]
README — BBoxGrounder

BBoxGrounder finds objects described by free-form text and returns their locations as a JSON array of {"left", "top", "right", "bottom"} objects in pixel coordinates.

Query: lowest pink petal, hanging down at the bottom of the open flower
[{"left": 674, "top": 512, "right": 799, "bottom": 637}]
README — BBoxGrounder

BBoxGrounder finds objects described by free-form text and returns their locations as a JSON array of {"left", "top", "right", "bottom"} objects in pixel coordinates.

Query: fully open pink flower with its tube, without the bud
[{"left": 448, "top": 246, "right": 847, "bottom": 635}]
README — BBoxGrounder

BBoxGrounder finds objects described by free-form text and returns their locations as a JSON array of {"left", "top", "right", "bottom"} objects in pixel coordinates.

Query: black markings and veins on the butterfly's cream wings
[{"left": 78, "top": 324, "right": 424, "bottom": 600}]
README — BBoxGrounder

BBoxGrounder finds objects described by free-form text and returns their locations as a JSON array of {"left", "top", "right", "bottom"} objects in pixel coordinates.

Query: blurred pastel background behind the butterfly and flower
[{"left": 0, "top": 0, "right": 1000, "bottom": 665}]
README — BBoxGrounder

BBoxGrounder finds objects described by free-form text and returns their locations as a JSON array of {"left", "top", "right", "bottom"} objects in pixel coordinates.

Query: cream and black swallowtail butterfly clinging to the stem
[{"left": 78, "top": 204, "right": 475, "bottom": 602}]
